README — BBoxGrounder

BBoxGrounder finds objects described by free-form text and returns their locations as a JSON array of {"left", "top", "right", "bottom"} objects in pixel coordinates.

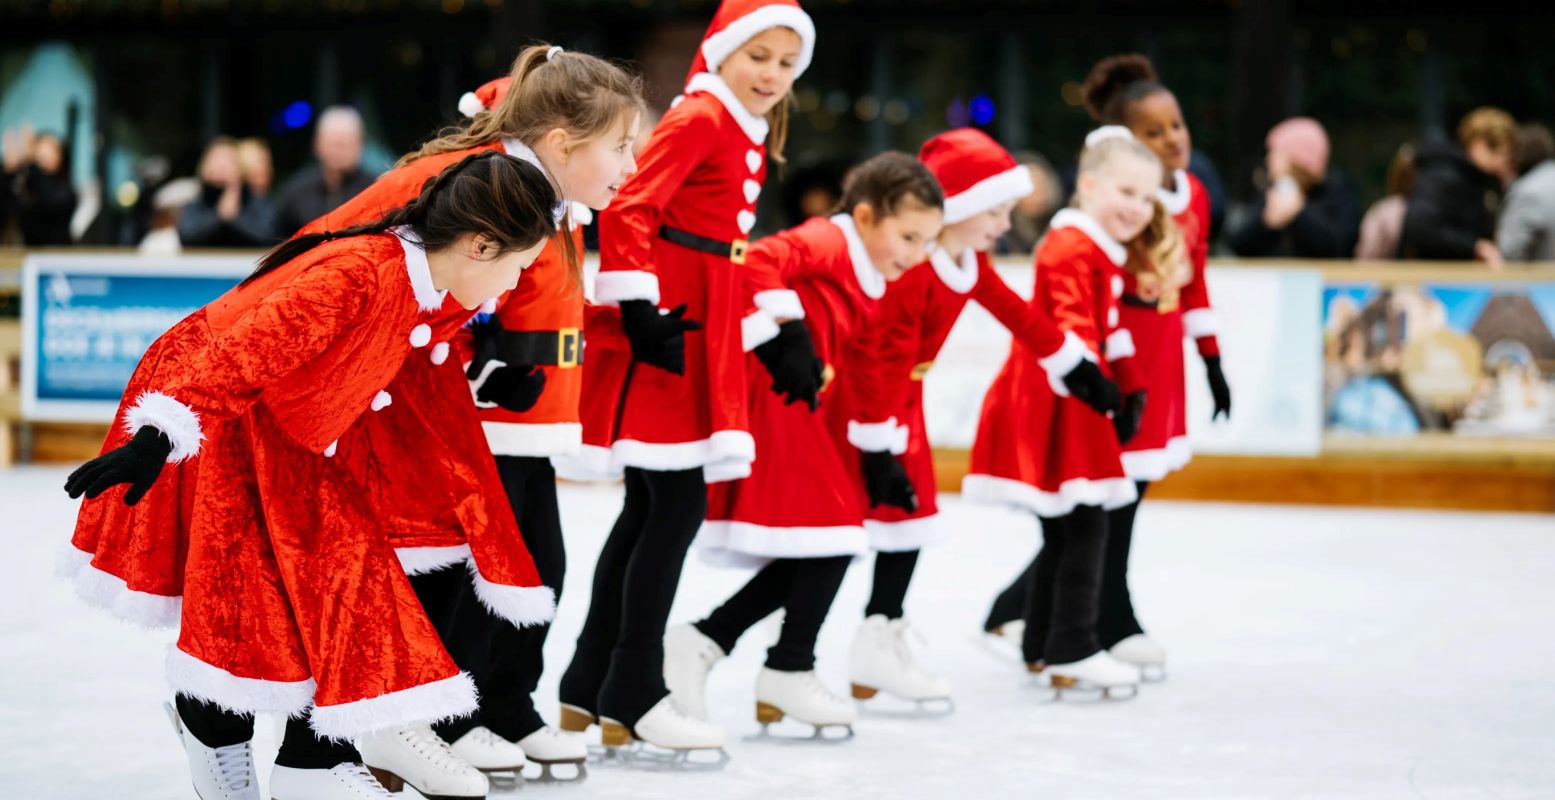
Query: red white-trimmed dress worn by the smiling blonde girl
[{"left": 961, "top": 209, "right": 1137, "bottom": 517}]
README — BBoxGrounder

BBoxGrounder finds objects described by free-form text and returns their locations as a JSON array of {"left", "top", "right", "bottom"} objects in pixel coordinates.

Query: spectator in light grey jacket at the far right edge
[{"left": 1496, "top": 123, "right": 1555, "bottom": 261}]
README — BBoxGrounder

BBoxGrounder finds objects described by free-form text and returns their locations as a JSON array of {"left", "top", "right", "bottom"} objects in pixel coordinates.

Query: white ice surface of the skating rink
[{"left": 0, "top": 468, "right": 1555, "bottom": 800}]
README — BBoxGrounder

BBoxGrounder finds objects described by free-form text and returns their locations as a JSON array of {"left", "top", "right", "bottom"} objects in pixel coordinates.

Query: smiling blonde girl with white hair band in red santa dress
[{"left": 963, "top": 126, "right": 1182, "bottom": 696}]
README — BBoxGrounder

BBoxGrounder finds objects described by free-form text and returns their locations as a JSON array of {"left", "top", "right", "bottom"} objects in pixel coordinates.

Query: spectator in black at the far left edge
[{"left": 0, "top": 126, "right": 76, "bottom": 247}]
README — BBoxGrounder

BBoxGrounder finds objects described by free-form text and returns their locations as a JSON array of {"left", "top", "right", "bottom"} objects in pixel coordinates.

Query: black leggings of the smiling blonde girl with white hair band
[{"left": 1043, "top": 506, "right": 1107, "bottom": 665}]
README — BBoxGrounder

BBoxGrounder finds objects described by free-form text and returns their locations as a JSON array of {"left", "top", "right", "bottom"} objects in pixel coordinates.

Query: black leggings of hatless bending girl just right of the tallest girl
[{"left": 695, "top": 556, "right": 852, "bottom": 672}]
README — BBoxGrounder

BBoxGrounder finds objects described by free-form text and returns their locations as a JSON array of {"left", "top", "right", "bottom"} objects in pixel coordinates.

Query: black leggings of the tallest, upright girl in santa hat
[{"left": 558, "top": 467, "right": 708, "bottom": 727}]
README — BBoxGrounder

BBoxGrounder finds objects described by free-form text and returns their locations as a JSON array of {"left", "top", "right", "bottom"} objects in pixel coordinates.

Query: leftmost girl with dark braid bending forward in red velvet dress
[{"left": 67, "top": 153, "right": 555, "bottom": 800}]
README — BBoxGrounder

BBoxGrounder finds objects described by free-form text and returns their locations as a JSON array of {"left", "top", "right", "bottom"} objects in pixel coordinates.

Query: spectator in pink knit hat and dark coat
[{"left": 1230, "top": 117, "right": 1361, "bottom": 258}]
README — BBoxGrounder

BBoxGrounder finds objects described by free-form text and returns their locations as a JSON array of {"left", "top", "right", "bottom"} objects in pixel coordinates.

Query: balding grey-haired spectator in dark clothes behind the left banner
[{"left": 275, "top": 106, "right": 375, "bottom": 238}]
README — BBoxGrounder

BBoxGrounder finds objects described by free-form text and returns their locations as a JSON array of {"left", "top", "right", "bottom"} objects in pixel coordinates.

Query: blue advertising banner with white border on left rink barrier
[{"left": 22, "top": 255, "right": 253, "bottom": 422}]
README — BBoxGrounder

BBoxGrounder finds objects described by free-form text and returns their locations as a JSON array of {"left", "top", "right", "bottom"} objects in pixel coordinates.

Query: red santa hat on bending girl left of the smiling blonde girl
[{"left": 917, "top": 128, "right": 1036, "bottom": 224}]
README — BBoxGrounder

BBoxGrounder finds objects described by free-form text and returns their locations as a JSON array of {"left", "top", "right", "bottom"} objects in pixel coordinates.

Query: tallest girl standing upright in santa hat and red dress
[{"left": 560, "top": 0, "right": 819, "bottom": 753}]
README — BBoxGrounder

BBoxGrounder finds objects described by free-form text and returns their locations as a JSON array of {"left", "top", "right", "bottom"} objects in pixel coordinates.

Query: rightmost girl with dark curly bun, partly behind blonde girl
[{"left": 984, "top": 54, "right": 1232, "bottom": 677}]
